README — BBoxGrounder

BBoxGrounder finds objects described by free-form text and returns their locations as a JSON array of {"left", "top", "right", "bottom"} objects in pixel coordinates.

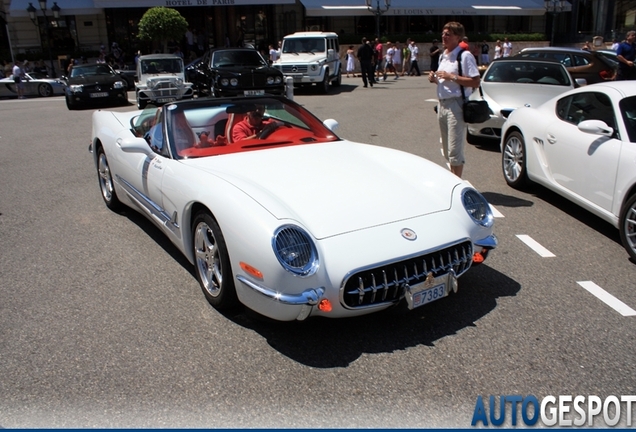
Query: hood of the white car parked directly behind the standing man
[{"left": 480, "top": 83, "right": 574, "bottom": 109}]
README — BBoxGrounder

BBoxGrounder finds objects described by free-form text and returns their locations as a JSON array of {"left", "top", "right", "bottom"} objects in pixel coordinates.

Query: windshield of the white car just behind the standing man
[{"left": 484, "top": 61, "right": 571, "bottom": 86}]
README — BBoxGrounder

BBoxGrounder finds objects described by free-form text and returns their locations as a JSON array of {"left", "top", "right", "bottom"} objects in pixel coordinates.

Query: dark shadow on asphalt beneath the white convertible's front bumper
[{"left": 226, "top": 265, "right": 521, "bottom": 368}]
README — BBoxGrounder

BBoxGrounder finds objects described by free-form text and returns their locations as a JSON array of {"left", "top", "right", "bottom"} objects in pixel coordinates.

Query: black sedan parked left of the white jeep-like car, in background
[{"left": 65, "top": 63, "right": 128, "bottom": 110}]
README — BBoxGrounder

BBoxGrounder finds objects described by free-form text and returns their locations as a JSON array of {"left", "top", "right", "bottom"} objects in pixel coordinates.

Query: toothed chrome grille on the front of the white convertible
[{"left": 342, "top": 241, "right": 473, "bottom": 308}]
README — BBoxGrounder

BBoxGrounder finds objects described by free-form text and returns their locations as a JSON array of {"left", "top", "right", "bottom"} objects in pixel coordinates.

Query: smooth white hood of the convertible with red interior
[{"left": 184, "top": 141, "right": 462, "bottom": 239}]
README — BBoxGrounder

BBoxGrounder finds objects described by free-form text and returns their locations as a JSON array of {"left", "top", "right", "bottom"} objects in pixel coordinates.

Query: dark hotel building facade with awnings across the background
[{"left": 0, "top": 0, "right": 636, "bottom": 71}]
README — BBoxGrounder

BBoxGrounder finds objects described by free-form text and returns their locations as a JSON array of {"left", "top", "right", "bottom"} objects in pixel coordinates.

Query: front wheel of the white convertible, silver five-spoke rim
[{"left": 192, "top": 211, "right": 238, "bottom": 310}]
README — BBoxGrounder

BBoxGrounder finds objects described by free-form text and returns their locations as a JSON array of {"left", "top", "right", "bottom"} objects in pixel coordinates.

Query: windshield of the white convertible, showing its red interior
[{"left": 161, "top": 97, "right": 339, "bottom": 159}]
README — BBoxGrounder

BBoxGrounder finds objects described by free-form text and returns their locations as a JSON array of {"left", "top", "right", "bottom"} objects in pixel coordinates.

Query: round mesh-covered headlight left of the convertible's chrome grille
[{"left": 272, "top": 225, "right": 318, "bottom": 276}]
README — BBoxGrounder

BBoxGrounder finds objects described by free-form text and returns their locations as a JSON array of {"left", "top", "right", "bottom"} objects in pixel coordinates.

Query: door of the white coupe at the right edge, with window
[{"left": 543, "top": 91, "right": 621, "bottom": 210}]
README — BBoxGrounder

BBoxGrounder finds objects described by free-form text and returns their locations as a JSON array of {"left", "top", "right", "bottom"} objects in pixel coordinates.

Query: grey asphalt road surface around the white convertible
[{"left": 0, "top": 76, "right": 636, "bottom": 428}]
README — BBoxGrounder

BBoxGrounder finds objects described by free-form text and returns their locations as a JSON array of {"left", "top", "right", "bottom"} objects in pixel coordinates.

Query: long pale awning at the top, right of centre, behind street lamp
[{"left": 300, "top": 0, "right": 545, "bottom": 16}]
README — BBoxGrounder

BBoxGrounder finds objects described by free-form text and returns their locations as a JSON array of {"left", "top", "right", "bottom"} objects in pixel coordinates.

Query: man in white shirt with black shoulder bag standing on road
[{"left": 428, "top": 22, "right": 480, "bottom": 177}]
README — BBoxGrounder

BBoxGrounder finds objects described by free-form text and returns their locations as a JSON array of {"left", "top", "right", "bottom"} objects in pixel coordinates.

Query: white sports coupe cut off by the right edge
[{"left": 501, "top": 81, "right": 636, "bottom": 260}]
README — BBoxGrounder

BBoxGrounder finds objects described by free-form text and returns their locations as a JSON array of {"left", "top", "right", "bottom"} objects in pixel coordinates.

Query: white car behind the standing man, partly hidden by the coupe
[{"left": 466, "top": 57, "right": 585, "bottom": 144}]
